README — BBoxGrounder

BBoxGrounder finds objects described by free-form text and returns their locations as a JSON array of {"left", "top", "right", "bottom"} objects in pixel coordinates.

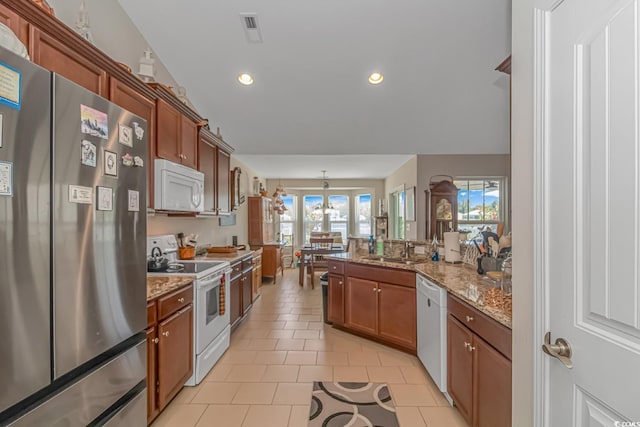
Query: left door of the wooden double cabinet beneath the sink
[{"left": 344, "top": 277, "right": 378, "bottom": 335}]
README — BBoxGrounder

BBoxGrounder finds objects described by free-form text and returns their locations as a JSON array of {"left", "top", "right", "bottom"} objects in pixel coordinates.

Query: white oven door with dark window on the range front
[{"left": 195, "top": 273, "right": 229, "bottom": 354}]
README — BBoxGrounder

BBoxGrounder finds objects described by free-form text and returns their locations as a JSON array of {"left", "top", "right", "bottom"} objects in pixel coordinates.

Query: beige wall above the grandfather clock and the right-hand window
[{"left": 416, "top": 154, "right": 511, "bottom": 240}]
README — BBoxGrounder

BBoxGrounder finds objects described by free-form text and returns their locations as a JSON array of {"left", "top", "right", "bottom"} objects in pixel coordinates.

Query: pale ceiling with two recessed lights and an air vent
[{"left": 119, "top": 0, "right": 511, "bottom": 178}]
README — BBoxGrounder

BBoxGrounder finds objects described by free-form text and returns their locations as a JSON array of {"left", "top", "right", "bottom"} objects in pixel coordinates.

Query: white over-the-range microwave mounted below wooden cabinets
[{"left": 153, "top": 159, "right": 204, "bottom": 212}]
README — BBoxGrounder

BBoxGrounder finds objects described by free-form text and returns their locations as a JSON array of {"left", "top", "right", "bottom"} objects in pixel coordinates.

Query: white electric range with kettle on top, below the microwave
[{"left": 147, "top": 235, "right": 231, "bottom": 386}]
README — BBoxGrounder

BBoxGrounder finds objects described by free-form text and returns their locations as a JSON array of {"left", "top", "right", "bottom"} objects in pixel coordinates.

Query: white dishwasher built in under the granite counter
[{"left": 416, "top": 274, "right": 452, "bottom": 403}]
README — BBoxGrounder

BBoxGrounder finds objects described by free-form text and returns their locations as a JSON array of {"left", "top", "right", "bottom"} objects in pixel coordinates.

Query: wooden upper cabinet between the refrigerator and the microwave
[{"left": 109, "top": 77, "right": 156, "bottom": 206}]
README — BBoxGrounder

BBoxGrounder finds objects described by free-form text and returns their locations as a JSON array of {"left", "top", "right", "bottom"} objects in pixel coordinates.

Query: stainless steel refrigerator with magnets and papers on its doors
[{"left": 0, "top": 49, "right": 147, "bottom": 426}]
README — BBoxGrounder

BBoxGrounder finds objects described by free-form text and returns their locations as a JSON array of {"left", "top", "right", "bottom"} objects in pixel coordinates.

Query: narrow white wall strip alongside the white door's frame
[{"left": 511, "top": 0, "right": 542, "bottom": 427}]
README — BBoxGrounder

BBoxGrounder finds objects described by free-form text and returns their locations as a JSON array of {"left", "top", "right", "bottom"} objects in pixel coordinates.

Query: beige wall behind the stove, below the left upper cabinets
[{"left": 147, "top": 155, "right": 256, "bottom": 246}]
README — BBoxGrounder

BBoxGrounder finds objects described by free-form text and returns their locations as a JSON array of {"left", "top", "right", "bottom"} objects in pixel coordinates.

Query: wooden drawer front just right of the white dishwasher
[{"left": 447, "top": 295, "right": 511, "bottom": 360}]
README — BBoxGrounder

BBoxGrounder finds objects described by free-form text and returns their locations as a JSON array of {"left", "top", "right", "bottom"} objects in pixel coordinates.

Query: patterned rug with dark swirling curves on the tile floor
[{"left": 308, "top": 382, "right": 400, "bottom": 427}]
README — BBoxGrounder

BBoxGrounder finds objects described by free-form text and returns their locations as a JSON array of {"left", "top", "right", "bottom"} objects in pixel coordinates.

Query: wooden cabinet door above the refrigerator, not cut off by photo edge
[{"left": 29, "top": 26, "right": 109, "bottom": 98}]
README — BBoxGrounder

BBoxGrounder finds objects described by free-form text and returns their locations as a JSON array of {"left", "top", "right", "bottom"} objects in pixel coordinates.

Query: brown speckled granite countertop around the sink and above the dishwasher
[{"left": 330, "top": 253, "right": 511, "bottom": 329}]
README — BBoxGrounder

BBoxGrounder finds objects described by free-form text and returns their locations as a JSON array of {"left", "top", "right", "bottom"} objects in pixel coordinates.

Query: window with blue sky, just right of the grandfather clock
[{"left": 453, "top": 178, "right": 505, "bottom": 239}]
